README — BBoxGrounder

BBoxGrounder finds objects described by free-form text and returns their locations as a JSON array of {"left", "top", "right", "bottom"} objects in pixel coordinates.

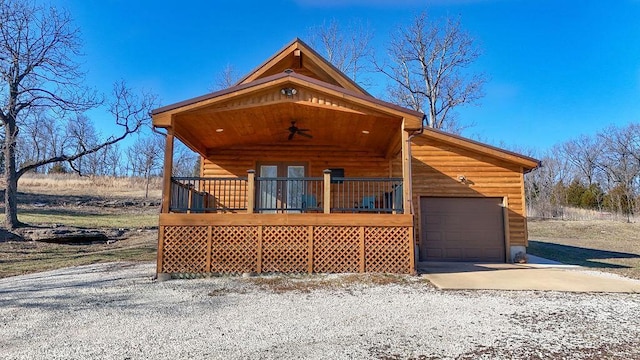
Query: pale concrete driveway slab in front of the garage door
[{"left": 418, "top": 256, "right": 640, "bottom": 293}]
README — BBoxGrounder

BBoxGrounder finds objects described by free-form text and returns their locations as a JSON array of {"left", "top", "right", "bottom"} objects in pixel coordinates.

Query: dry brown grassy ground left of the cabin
[{"left": 0, "top": 174, "right": 161, "bottom": 277}]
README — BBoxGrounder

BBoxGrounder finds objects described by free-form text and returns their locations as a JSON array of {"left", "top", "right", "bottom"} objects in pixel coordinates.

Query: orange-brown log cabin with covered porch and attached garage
[{"left": 152, "top": 39, "right": 538, "bottom": 276}]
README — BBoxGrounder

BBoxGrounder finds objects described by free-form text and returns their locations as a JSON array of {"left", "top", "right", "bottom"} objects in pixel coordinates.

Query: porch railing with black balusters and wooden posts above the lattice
[{"left": 169, "top": 170, "right": 404, "bottom": 214}]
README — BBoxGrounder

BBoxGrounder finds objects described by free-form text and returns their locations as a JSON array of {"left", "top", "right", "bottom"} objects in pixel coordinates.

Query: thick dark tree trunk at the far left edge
[{"left": 4, "top": 121, "right": 20, "bottom": 230}]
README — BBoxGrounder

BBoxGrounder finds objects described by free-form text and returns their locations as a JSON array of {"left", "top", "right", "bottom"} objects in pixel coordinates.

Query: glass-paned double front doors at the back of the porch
[{"left": 257, "top": 163, "right": 306, "bottom": 213}]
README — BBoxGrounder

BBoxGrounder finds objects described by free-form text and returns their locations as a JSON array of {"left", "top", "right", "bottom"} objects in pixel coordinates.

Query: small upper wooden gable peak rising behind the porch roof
[{"left": 236, "top": 38, "right": 371, "bottom": 96}]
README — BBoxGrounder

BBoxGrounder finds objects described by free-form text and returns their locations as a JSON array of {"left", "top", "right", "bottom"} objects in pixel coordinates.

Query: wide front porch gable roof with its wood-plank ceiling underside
[{"left": 151, "top": 72, "right": 423, "bottom": 156}]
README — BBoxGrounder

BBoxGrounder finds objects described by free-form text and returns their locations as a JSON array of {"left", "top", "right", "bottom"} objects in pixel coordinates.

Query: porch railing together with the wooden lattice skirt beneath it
[{"left": 158, "top": 169, "right": 415, "bottom": 274}]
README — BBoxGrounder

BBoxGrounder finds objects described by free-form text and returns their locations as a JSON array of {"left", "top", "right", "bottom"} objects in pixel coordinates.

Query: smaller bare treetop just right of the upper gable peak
[{"left": 309, "top": 19, "right": 373, "bottom": 86}]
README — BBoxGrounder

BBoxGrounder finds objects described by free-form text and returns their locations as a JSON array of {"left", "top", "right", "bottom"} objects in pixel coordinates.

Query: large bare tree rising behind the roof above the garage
[{"left": 374, "top": 12, "right": 486, "bottom": 132}]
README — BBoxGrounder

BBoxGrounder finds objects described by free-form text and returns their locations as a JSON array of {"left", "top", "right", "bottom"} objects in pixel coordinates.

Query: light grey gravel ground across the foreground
[{"left": 0, "top": 263, "right": 640, "bottom": 359}]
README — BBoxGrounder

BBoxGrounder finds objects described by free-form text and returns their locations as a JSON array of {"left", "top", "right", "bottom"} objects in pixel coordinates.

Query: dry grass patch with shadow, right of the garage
[{"left": 528, "top": 220, "right": 640, "bottom": 279}]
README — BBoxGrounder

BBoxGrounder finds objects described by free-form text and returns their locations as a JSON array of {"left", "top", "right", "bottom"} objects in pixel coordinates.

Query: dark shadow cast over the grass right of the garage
[{"left": 527, "top": 240, "right": 640, "bottom": 269}]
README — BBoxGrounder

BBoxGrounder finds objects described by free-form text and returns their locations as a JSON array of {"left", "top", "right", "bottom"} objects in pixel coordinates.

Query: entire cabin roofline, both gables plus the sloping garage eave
[{"left": 151, "top": 38, "right": 540, "bottom": 172}]
